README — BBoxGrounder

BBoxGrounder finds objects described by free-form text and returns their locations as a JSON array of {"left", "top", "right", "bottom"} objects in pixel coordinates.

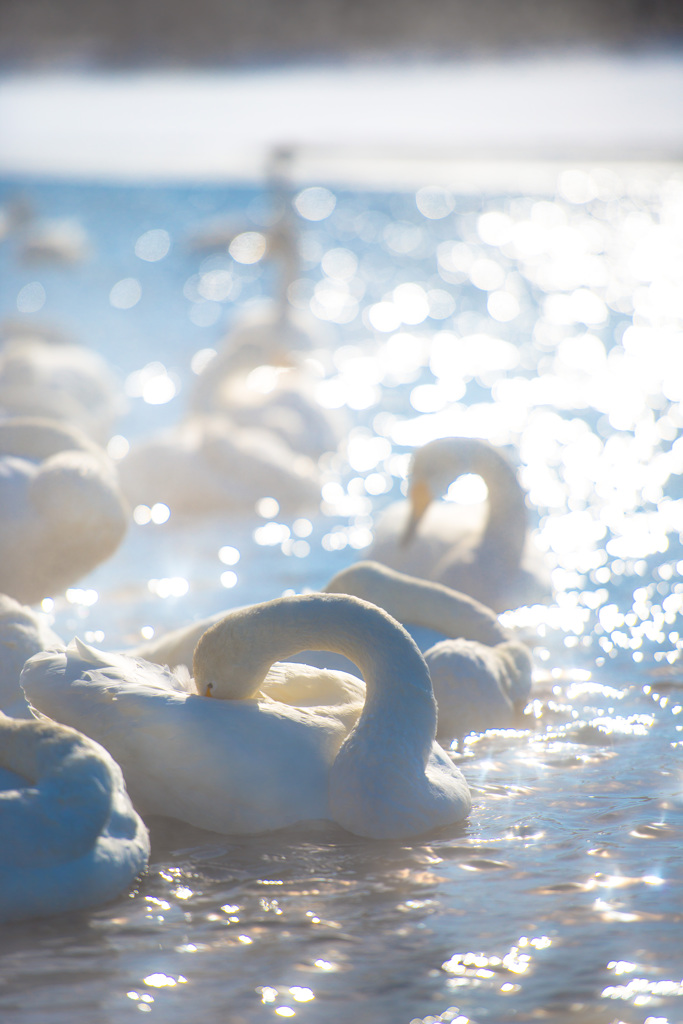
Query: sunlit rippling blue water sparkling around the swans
[{"left": 0, "top": 161, "right": 683, "bottom": 1024}]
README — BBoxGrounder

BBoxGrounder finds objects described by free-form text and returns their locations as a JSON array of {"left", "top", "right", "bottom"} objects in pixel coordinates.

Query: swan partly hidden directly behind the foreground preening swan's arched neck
[{"left": 129, "top": 561, "right": 532, "bottom": 739}]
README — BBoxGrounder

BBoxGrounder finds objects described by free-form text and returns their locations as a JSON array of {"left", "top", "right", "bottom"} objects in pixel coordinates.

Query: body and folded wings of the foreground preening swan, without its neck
[{"left": 22, "top": 639, "right": 347, "bottom": 834}]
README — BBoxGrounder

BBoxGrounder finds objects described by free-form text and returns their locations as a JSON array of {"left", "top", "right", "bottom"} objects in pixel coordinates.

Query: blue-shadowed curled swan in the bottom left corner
[{"left": 0, "top": 714, "right": 150, "bottom": 922}]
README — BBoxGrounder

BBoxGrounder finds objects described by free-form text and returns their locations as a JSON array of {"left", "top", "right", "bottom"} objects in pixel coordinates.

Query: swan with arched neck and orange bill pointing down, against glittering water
[{"left": 368, "top": 437, "right": 551, "bottom": 611}]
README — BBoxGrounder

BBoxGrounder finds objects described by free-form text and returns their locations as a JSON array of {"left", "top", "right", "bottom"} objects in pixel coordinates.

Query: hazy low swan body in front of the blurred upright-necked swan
[{"left": 118, "top": 416, "right": 321, "bottom": 516}]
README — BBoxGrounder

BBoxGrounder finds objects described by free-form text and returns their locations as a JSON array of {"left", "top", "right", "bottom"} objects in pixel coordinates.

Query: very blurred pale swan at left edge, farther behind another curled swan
[{"left": 0, "top": 323, "right": 125, "bottom": 444}]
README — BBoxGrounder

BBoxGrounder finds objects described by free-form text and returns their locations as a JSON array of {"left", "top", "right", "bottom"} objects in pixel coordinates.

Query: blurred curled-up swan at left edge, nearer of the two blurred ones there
[{"left": 0, "top": 417, "right": 128, "bottom": 604}]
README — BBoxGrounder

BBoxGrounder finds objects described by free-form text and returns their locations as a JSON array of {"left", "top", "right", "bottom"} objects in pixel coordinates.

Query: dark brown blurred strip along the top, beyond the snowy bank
[{"left": 0, "top": 0, "right": 683, "bottom": 68}]
